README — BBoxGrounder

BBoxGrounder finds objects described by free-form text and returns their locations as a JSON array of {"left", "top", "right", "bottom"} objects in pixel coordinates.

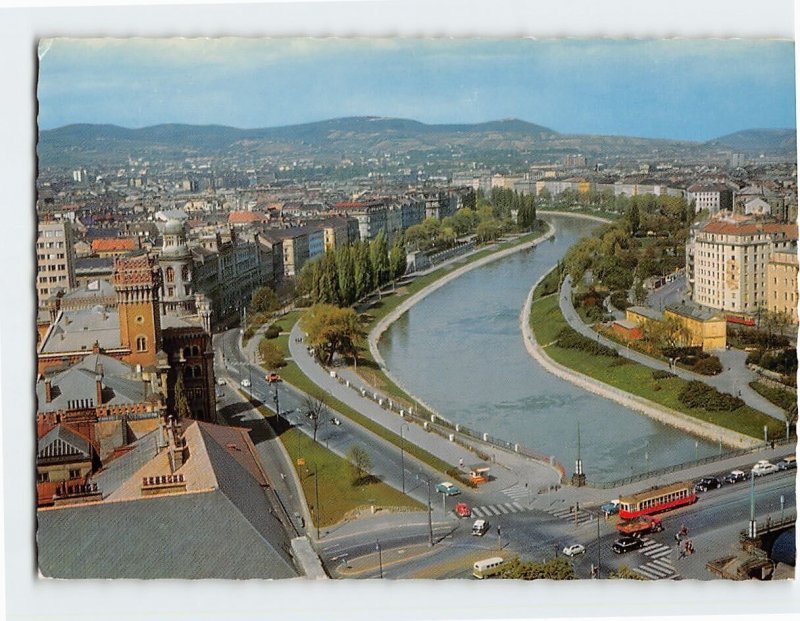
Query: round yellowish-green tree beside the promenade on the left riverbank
[{"left": 300, "top": 304, "right": 364, "bottom": 365}]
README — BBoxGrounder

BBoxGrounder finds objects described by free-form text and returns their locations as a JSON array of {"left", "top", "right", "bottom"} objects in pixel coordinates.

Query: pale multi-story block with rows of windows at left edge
[{"left": 36, "top": 220, "right": 75, "bottom": 308}]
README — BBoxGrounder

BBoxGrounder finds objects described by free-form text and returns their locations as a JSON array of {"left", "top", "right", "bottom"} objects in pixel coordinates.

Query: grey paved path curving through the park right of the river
[{"left": 559, "top": 276, "right": 785, "bottom": 422}]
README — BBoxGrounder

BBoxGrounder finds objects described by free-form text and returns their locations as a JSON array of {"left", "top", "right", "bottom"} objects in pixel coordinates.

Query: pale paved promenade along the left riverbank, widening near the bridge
[{"left": 289, "top": 318, "right": 559, "bottom": 493}]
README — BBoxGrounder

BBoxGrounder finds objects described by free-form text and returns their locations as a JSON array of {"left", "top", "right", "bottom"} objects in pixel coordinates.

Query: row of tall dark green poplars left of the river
[{"left": 298, "top": 230, "right": 406, "bottom": 306}]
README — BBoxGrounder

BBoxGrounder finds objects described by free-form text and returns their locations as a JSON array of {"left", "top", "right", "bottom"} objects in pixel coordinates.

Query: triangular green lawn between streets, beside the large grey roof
[{"left": 281, "top": 428, "right": 423, "bottom": 527}]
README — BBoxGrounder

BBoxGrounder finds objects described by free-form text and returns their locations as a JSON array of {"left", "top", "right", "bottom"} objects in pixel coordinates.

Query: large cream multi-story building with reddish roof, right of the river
[{"left": 686, "top": 215, "right": 797, "bottom": 314}]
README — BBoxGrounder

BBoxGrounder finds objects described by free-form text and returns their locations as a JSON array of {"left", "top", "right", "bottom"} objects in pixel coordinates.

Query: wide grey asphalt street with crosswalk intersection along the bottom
[{"left": 215, "top": 318, "right": 795, "bottom": 579}]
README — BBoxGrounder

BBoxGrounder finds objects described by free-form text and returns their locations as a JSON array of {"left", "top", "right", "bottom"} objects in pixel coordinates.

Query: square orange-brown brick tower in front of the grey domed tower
[{"left": 113, "top": 253, "right": 161, "bottom": 367}]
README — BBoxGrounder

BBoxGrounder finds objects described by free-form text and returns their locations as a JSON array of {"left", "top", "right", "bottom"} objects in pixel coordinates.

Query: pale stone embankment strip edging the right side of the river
[{"left": 520, "top": 272, "right": 761, "bottom": 448}]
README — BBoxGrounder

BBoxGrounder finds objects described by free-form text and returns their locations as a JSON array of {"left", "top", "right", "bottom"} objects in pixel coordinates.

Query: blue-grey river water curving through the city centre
[{"left": 379, "top": 216, "right": 719, "bottom": 481}]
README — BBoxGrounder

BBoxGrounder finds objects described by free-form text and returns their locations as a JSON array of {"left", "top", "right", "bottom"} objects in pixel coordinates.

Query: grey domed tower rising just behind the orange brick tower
[{"left": 159, "top": 219, "right": 195, "bottom": 316}]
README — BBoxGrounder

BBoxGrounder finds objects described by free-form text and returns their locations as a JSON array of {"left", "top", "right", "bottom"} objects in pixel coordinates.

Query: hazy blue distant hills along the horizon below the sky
[{"left": 38, "top": 116, "right": 795, "bottom": 167}]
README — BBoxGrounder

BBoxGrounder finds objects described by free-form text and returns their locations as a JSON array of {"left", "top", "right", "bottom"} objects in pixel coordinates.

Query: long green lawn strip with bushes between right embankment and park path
[{"left": 531, "top": 296, "right": 783, "bottom": 438}]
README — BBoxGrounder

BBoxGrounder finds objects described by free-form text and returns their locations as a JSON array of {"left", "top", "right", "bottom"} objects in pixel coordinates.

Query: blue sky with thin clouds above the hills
[{"left": 38, "top": 38, "right": 795, "bottom": 140}]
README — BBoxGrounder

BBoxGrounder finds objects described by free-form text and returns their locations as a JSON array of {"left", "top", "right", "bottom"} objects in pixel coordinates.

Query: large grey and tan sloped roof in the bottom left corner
[{"left": 37, "top": 423, "right": 298, "bottom": 579}]
